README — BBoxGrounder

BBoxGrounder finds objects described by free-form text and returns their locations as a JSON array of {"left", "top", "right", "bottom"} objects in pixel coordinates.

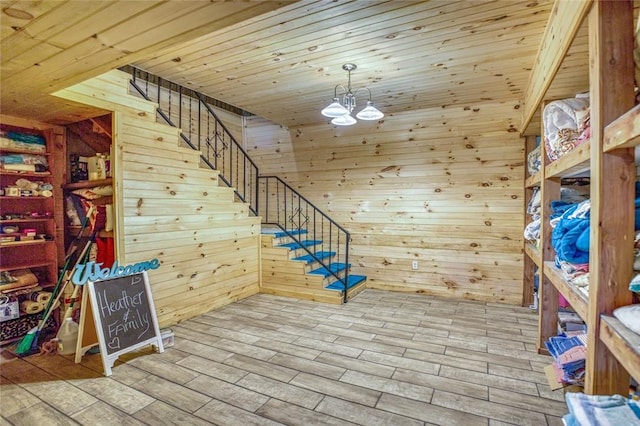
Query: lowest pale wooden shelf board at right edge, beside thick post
[{"left": 600, "top": 315, "right": 640, "bottom": 381}]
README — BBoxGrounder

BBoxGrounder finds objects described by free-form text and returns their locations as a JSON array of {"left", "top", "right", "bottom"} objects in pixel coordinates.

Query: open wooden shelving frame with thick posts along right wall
[{"left": 524, "top": 1, "right": 640, "bottom": 395}]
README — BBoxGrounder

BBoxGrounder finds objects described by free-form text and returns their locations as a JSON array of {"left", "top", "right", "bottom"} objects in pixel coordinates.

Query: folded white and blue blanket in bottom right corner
[{"left": 565, "top": 392, "right": 640, "bottom": 426}]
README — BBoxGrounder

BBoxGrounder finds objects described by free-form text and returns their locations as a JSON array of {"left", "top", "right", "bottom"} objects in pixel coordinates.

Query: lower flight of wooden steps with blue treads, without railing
[{"left": 260, "top": 226, "right": 366, "bottom": 304}]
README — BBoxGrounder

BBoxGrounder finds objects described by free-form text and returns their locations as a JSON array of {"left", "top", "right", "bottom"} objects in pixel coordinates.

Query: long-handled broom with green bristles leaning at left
[{"left": 15, "top": 206, "right": 95, "bottom": 356}]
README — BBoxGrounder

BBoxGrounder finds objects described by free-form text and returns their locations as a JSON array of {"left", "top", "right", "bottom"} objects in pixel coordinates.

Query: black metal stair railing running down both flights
[{"left": 120, "top": 65, "right": 350, "bottom": 302}]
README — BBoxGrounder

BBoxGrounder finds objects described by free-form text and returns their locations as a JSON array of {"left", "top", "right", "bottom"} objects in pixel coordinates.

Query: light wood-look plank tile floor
[{"left": 0, "top": 289, "right": 567, "bottom": 426}]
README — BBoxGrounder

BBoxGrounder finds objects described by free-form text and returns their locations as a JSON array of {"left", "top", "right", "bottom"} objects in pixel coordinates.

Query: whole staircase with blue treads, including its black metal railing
[{"left": 122, "top": 66, "right": 366, "bottom": 303}]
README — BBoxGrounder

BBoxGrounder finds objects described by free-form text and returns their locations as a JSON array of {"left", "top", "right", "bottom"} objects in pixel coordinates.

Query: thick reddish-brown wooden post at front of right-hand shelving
[{"left": 585, "top": 0, "right": 635, "bottom": 395}]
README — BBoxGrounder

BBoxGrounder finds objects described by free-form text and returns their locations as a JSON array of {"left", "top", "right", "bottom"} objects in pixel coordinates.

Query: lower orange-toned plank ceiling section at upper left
[{"left": 0, "top": 0, "right": 291, "bottom": 124}]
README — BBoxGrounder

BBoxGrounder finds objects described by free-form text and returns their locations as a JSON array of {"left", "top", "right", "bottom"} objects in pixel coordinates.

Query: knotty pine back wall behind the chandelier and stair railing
[{"left": 245, "top": 103, "right": 524, "bottom": 304}]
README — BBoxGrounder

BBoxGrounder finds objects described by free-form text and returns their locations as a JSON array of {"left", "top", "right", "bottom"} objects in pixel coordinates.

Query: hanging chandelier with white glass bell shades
[{"left": 321, "top": 64, "right": 384, "bottom": 126}]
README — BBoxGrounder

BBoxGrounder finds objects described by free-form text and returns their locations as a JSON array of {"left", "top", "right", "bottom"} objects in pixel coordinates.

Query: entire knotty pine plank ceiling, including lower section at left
[{"left": 0, "top": 0, "right": 588, "bottom": 130}]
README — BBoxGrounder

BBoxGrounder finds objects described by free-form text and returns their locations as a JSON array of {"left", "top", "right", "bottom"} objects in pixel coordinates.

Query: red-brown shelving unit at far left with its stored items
[{"left": 0, "top": 116, "right": 59, "bottom": 344}]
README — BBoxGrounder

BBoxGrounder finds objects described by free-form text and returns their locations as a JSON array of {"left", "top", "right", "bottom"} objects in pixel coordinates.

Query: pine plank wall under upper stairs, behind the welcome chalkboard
[{"left": 58, "top": 71, "right": 260, "bottom": 327}]
